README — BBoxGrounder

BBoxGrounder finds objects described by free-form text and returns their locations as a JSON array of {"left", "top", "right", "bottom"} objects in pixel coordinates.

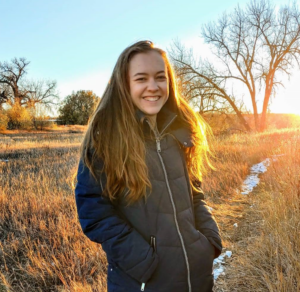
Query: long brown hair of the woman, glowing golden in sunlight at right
[{"left": 81, "top": 41, "right": 209, "bottom": 204}]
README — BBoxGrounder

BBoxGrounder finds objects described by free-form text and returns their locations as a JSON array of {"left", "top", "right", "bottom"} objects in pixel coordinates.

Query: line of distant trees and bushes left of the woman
[{"left": 0, "top": 58, "right": 99, "bottom": 130}]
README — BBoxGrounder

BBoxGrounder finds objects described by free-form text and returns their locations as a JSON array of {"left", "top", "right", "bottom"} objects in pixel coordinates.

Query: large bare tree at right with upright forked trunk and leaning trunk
[{"left": 174, "top": 0, "right": 300, "bottom": 131}]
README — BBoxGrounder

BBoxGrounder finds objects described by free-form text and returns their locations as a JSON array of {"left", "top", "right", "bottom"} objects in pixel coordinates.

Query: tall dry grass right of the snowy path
[{"left": 218, "top": 132, "right": 300, "bottom": 292}]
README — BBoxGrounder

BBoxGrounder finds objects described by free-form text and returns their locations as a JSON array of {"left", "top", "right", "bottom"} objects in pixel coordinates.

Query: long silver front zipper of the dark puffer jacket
[{"left": 145, "top": 116, "right": 192, "bottom": 292}]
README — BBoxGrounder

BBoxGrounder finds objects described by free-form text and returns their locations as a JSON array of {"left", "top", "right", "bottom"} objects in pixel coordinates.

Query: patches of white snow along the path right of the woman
[{"left": 214, "top": 154, "right": 284, "bottom": 281}]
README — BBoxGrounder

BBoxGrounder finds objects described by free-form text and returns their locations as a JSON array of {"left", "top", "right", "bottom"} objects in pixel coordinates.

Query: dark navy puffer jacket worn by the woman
[{"left": 75, "top": 103, "right": 222, "bottom": 292}]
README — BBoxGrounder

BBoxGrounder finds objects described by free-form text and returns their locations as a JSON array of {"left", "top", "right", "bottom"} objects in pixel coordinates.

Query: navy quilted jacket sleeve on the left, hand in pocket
[{"left": 75, "top": 160, "right": 158, "bottom": 283}]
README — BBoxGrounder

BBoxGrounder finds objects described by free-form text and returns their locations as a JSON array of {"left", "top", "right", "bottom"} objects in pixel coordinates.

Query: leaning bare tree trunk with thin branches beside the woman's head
[{"left": 169, "top": 41, "right": 250, "bottom": 131}]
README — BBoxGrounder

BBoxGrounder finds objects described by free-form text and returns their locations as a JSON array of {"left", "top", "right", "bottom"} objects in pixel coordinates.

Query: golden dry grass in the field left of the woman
[{"left": 0, "top": 133, "right": 106, "bottom": 292}]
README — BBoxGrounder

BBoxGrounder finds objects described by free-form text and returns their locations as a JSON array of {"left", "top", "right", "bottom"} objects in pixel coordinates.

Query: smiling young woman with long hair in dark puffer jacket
[{"left": 75, "top": 41, "right": 222, "bottom": 292}]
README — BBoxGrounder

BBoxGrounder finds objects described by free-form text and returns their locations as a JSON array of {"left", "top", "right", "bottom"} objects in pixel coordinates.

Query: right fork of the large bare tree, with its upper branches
[{"left": 249, "top": 1, "right": 300, "bottom": 131}]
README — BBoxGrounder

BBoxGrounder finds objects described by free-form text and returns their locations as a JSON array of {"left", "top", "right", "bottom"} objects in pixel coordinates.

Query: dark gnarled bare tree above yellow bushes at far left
[{"left": 0, "top": 58, "right": 58, "bottom": 107}]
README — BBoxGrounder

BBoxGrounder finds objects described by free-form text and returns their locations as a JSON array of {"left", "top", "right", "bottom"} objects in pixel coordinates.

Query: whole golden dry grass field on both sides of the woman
[{"left": 0, "top": 128, "right": 300, "bottom": 292}]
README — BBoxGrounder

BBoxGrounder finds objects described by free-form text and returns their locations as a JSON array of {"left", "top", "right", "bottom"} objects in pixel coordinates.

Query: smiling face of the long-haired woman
[{"left": 128, "top": 51, "right": 169, "bottom": 123}]
